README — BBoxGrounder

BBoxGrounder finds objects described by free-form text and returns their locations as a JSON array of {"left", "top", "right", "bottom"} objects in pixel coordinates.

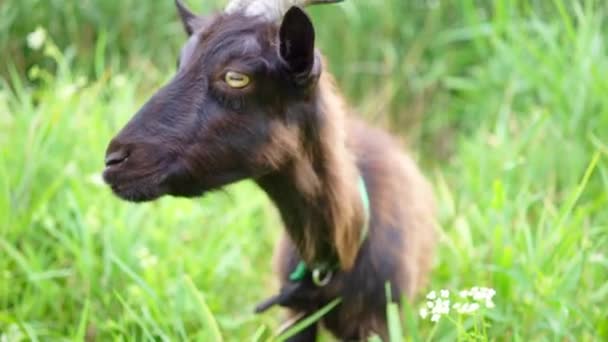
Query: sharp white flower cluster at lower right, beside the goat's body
[{"left": 420, "top": 286, "right": 496, "bottom": 322}]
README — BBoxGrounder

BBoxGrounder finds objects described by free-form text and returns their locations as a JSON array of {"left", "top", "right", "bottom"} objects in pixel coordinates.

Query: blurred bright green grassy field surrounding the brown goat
[{"left": 0, "top": 0, "right": 608, "bottom": 342}]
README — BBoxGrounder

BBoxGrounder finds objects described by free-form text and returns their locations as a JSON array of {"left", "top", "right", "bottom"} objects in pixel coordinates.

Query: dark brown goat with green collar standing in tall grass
[{"left": 104, "top": 3, "right": 435, "bottom": 341}]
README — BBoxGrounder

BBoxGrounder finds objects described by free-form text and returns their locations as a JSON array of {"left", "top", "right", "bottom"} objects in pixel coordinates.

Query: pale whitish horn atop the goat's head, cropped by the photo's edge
[{"left": 225, "top": 0, "right": 343, "bottom": 21}]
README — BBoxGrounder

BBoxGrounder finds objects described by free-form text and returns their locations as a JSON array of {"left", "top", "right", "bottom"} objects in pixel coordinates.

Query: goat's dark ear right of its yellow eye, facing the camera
[{"left": 279, "top": 6, "right": 316, "bottom": 79}]
